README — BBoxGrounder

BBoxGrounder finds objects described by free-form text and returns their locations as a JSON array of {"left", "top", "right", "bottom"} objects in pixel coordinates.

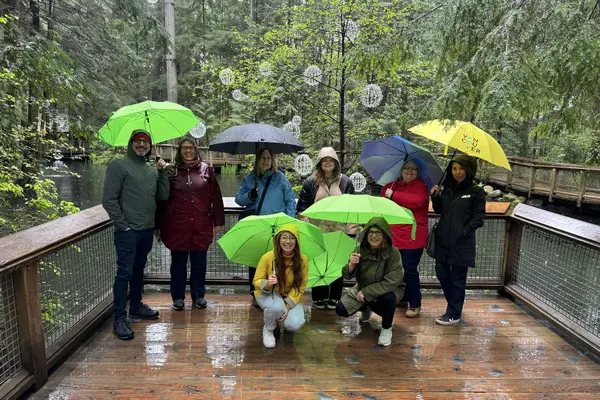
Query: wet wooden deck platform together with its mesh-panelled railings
[{"left": 0, "top": 198, "right": 600, "bottom": 400}]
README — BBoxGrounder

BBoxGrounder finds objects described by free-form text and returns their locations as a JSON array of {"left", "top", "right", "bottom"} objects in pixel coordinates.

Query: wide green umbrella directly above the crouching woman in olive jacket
[{"left": 302, "top": 194, "right": 417, "bottom": 240}]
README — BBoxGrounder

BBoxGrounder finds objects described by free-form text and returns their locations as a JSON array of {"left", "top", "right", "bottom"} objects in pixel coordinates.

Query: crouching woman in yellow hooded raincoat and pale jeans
[{"left": 253, "top": 224, "right": 308, "bottom": 348}]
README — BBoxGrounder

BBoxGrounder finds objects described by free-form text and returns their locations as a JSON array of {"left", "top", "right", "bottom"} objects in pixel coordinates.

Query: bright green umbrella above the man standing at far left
[{"left": 99, "top": 101, "right": 200, "bottom": 146}]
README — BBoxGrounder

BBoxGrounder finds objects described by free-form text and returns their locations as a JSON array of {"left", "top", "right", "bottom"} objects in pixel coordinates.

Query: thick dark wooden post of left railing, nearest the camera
[{"left": 13, "top": 260, "right": 48, "bottom": 391}]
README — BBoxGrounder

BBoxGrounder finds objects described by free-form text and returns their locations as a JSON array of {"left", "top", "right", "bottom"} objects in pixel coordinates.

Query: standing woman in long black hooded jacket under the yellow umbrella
[{"left": 431, "top": 155, "right": 485, "bottom": 325}]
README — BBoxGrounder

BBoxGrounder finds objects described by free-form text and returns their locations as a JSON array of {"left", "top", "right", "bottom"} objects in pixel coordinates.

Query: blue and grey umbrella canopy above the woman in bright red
[{"left": 360, "top": 136, "right": 444, "bottom": 189}]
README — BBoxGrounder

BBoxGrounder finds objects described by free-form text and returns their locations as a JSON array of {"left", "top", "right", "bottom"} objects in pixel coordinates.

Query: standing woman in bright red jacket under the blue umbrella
[{"left": 381, "top": 159, "right": 429, "bottom": 318}]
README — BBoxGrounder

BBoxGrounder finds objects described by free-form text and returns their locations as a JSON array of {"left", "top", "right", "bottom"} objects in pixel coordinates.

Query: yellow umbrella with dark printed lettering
[{"left": 408, "top": 119, "right": 511, "bottom": 171}]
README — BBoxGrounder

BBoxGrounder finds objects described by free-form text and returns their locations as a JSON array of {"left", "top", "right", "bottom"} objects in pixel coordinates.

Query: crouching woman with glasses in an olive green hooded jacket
[{"left": 335, "top": 217, "right": 404, "bottom": 346}]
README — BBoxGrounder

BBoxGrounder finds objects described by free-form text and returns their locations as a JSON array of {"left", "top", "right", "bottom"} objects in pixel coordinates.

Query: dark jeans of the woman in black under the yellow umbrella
[{"left": 435, "top": 260, "right": 469, "bottom": 318}]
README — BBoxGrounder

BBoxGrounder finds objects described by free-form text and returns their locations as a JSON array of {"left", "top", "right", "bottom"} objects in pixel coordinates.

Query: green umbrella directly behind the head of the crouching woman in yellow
[{"left": 218, "top": 213, "right": 325, "bottom": 267}]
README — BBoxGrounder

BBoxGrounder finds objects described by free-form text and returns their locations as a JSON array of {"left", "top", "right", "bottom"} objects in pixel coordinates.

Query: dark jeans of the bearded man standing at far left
[{"left": 113, "top": 229, "right": 154, "bottom": 321}]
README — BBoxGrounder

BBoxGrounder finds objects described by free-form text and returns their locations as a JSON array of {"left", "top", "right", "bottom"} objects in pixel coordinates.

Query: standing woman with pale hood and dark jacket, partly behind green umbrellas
[{"left": 296, "top": 147, "right": 356, "bottom": 310}]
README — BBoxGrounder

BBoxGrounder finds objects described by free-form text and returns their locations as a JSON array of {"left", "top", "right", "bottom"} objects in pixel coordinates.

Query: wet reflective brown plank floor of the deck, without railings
[{"left": 30, "top": 293, "right": 600, "bottom": 400}]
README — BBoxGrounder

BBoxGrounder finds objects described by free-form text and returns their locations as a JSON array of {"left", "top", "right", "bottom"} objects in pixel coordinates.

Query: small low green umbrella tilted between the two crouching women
[{"left": 307, "top": 231, "right": 355, "bottom": 287}]
